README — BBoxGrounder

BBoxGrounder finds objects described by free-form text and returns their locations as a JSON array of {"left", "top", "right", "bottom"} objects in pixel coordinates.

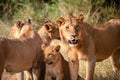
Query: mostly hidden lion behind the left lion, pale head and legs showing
[{"left": 6, "top": 19, "right": 33, "bottom": 80}]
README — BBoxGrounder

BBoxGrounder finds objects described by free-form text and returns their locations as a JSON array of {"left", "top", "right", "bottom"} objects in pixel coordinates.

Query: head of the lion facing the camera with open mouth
[{"left": 56, "top": 14, "right": 86, "bottom": 46}]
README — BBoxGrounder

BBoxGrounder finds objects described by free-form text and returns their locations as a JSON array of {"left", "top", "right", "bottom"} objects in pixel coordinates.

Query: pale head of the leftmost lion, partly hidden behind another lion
[{"left": 9, "top": 19, "right": 31, "bottom": 39}]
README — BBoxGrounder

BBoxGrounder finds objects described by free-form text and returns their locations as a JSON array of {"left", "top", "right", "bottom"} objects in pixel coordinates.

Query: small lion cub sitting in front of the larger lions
[{"left": 42, "top": 45, "right": 71, "bottom": 80}]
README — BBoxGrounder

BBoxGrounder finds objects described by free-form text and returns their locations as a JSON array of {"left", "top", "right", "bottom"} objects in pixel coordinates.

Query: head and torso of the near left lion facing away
[{"left": 0, "top": 19, "right": 43, "bottom": 80}]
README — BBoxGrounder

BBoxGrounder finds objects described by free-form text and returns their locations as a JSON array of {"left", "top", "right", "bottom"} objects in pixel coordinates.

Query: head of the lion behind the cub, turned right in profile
[{"left": 38, "top": 20, "right": 60, "bottom": 43}]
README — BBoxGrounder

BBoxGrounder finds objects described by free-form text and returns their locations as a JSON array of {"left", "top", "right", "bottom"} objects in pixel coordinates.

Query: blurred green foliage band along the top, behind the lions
[{"left": 0, "top": 0, "right": 120, "bottom": 32}]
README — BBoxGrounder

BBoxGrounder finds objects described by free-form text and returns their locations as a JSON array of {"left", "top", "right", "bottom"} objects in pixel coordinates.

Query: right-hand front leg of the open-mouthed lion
[{"left": 86, "top": 54, "right": 96, "bottom": 80}]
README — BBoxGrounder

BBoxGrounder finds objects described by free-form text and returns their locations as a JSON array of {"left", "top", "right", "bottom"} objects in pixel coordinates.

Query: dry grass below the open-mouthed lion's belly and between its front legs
[{"left": 79, "top": 59, "right": 120, "bottom": 80}]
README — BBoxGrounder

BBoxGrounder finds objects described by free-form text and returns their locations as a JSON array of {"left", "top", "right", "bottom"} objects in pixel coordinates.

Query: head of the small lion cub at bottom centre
[{"left": 42, "top": 45, "right": 60, "bottom": 65}]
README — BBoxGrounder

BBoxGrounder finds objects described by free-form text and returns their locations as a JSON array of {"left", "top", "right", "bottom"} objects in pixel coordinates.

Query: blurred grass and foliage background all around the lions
[{"left": 0, "top": 0, "right": 120, "bottom": 80}]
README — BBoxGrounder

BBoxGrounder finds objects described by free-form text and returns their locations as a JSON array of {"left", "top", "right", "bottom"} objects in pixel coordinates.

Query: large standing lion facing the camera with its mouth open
[{"left": 56, "top": 13, "right": 120, "bottom": 80}]
